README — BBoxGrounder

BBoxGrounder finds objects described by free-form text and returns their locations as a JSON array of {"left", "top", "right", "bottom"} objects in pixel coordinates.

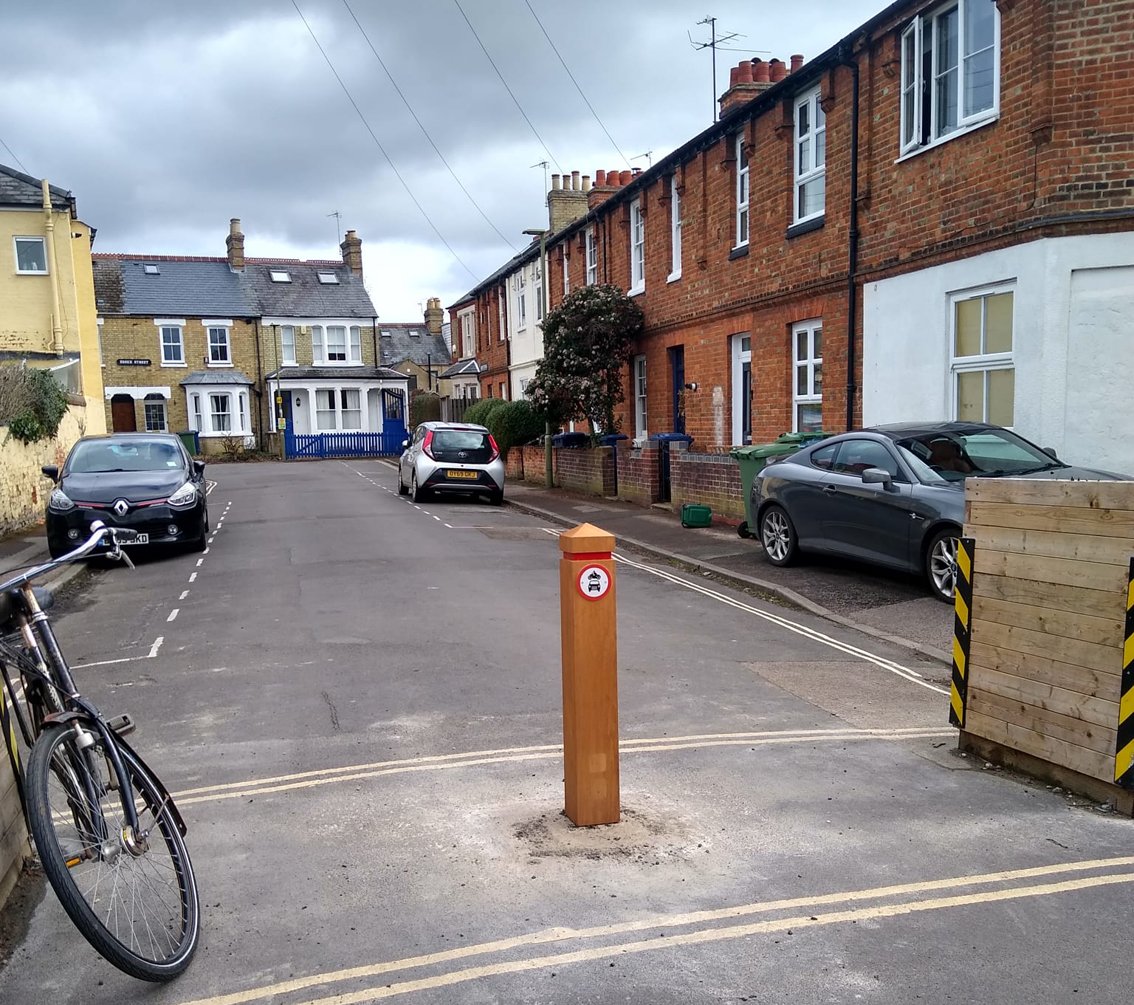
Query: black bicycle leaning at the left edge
[{"left": 0, "top": 521, "right": 201, "bottom": 981}]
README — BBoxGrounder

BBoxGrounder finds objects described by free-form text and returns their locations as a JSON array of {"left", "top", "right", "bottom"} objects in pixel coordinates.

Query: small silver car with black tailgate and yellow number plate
[{"left": 398, "top": 422, "right": 503, "bottom": 506}]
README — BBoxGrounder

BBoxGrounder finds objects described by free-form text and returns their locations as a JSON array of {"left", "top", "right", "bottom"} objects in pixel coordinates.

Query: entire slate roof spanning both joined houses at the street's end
[{"left": 92, "top": 254, "right": 375, "bottom": 323}]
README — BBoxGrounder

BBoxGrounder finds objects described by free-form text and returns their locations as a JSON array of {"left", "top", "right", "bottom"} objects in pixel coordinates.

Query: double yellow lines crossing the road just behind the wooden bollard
[{"left": 177, "top": 726, "right": 956, "bottom": 805}]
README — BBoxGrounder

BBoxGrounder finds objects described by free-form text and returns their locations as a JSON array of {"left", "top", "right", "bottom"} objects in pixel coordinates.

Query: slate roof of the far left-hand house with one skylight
[{"left": 92, "top": 254, "right": 248, "bottom": 318}]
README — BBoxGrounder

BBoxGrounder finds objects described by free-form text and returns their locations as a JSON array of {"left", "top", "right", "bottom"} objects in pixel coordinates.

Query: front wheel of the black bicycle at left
[{"left": 27, "top": 726, "right": 200, "bottom": 981}]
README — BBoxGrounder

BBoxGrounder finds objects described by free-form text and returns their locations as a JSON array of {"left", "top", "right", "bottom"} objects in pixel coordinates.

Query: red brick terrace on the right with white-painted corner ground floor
[{"left": 489, "top": 0, "right": 1134, "bottom": 471}]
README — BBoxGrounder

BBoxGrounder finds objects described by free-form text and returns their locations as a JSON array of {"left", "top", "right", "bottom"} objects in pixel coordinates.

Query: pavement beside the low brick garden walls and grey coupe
[{"left": 505, "top": 482, "right": 953, "bottom": 664}]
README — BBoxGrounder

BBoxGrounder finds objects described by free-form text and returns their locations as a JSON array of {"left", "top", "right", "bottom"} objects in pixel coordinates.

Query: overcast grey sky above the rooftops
[{"left": 0, "top": 0, "right": 888, "bottom": 321}]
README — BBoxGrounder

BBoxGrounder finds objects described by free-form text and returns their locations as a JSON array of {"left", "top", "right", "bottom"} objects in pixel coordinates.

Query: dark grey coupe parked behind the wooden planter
[{"left": 751, "top": 422, "right": 1128, "bottom": 603}]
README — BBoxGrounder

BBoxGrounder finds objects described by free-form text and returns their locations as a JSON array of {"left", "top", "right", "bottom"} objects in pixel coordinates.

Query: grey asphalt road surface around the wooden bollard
[{"left": 0, "top": 462, "right": 1134, "bottom": 1005}]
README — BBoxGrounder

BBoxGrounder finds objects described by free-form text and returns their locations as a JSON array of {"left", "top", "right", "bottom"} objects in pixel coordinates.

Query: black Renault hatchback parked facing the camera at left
[{"left": 43, "top": 433, "right": 209, "bottom": 558}]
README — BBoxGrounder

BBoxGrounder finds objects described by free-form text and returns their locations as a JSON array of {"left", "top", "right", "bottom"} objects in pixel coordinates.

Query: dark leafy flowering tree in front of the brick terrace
[{"left": 527, "top": 285, "right": 644, "bottom": 433}]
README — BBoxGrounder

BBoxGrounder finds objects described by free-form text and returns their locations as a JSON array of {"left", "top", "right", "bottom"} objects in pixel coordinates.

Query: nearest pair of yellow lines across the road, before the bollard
[{"left": 170, "top": 858, "right": 1134, "bottom": 1005}]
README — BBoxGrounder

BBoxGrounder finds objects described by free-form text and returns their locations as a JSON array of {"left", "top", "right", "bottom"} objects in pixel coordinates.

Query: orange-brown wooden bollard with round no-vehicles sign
[{"left": 559, "top": 523, "right": 621, "bottom": 827}]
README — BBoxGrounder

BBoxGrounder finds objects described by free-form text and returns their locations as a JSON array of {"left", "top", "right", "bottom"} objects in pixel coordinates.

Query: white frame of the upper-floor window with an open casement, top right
[{"left": 898, "top": 0, "right": 1002, "bottom": 159}]
